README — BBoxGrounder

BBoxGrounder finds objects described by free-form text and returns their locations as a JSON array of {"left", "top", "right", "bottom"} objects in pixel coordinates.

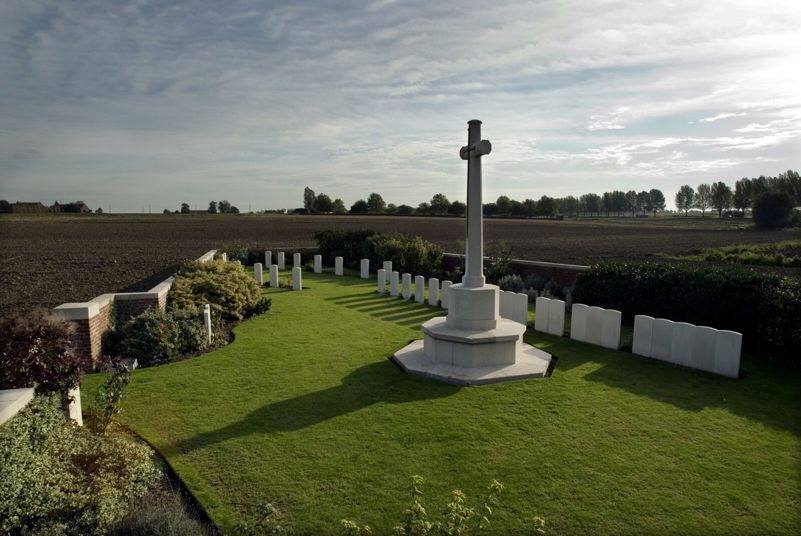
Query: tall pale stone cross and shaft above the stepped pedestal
[{"left": 459, "top": 119, "right": 492, "bottom": 288}]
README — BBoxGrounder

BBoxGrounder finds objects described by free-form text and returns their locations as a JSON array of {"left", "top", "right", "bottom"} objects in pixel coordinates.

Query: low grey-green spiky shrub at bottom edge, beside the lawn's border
[{"left": 106, "top": 490, "right": 210, "bottom": 536}]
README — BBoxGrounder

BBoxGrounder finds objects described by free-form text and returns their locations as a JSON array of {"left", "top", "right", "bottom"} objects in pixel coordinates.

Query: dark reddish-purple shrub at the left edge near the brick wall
[{"left": 0, "top": 311, "right": 86, "bottom": 394}]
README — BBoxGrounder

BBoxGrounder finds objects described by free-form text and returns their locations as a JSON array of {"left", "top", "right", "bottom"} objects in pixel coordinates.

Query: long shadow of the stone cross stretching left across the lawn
[{"left": 175, "top": 360, "right": 460, "bottom": 452}]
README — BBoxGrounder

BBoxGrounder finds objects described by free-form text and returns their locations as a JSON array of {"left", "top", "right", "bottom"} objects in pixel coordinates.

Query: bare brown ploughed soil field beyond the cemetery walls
[{"left": 0, "top": 214, "right": 801, "bottom": 314}]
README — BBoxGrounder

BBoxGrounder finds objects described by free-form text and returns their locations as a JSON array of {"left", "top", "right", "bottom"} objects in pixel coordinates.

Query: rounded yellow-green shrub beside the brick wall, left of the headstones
[{"left": 169, "top": 261, "right": 270, "bottom": 320}]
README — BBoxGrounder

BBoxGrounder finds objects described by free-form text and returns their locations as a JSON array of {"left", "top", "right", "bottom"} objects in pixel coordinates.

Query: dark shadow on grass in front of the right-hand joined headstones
[{"left": 526, "top": 330, "right": 801, "bottom": 436}]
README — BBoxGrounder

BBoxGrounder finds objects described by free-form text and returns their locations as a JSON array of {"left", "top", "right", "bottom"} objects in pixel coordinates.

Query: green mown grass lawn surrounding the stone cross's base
[{"left": 83, "top": 273, "right": 801, "bottom": 535}]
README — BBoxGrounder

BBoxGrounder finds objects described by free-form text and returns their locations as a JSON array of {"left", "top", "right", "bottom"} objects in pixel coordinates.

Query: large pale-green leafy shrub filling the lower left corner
[{"left": 0, "top": 395, "right": 161, "bottom": 535}]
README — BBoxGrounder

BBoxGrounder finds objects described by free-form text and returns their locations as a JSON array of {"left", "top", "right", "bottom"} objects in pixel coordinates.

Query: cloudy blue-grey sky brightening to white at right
[{"left": 0, "top": 0, "right": 801, "bottom": 212}]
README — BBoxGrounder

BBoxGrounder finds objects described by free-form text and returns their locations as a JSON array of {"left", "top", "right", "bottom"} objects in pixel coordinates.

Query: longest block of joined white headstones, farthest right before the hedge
[{"left": 631, "top": 315, "right": 743, "bottom": 378}]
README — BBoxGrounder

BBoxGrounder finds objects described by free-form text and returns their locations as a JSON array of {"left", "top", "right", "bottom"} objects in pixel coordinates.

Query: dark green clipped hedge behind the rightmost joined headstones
[{"left": 573, "top": 263, "right": 801, "bottom": 365}]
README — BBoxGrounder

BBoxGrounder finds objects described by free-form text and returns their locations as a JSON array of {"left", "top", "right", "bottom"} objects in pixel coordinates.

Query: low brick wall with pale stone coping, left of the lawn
[{"left": 53, "top": 250, "right": 216, "bottom": 366}]
